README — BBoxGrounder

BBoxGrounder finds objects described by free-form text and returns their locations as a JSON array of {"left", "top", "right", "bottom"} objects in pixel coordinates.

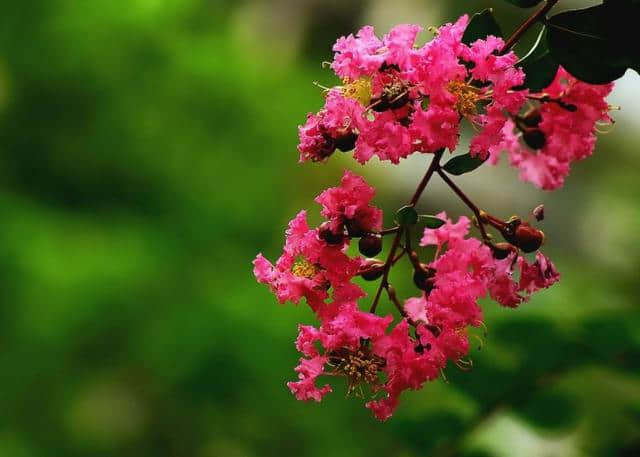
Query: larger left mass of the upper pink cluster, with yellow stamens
[{"left": 298, "top": 16, "right": 526, "bottom": 168}]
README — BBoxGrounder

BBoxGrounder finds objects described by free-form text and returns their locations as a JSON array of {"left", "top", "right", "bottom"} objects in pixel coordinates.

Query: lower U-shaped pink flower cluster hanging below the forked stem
[{"left": 254, "top": 171, "right": 558, "bottom": 420}]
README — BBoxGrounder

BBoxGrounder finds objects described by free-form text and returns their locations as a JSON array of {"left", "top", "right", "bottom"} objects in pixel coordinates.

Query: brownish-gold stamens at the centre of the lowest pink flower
[{"left": 329, "top": 346, "right": 386, "bottom": 395}]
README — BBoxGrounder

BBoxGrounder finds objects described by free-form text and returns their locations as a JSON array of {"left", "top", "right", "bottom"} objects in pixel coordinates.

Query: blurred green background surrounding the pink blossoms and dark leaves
[{"left": 0, "top": 0, "right": 640, "bottom": 457}]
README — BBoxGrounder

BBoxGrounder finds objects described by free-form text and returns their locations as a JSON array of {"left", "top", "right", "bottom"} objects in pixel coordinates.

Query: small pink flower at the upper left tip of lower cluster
[{"left": 316, "top": 170, "right": 382, "bottom": 233}]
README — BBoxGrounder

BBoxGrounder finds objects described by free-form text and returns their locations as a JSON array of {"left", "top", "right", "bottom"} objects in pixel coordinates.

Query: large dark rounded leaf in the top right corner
[{"left": 547, "top": 5, "right": 634, "bottom": 84}]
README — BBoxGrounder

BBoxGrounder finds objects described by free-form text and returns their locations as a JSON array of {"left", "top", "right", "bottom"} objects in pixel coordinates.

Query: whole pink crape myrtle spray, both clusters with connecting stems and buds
[{"left": 253, "top": 10, "right": 612, "bottom": 420}]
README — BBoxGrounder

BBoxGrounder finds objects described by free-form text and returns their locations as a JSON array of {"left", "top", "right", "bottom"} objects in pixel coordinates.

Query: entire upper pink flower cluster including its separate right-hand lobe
[{"left": 298, "top": 15, "right": 612, "bottom": 189}]
